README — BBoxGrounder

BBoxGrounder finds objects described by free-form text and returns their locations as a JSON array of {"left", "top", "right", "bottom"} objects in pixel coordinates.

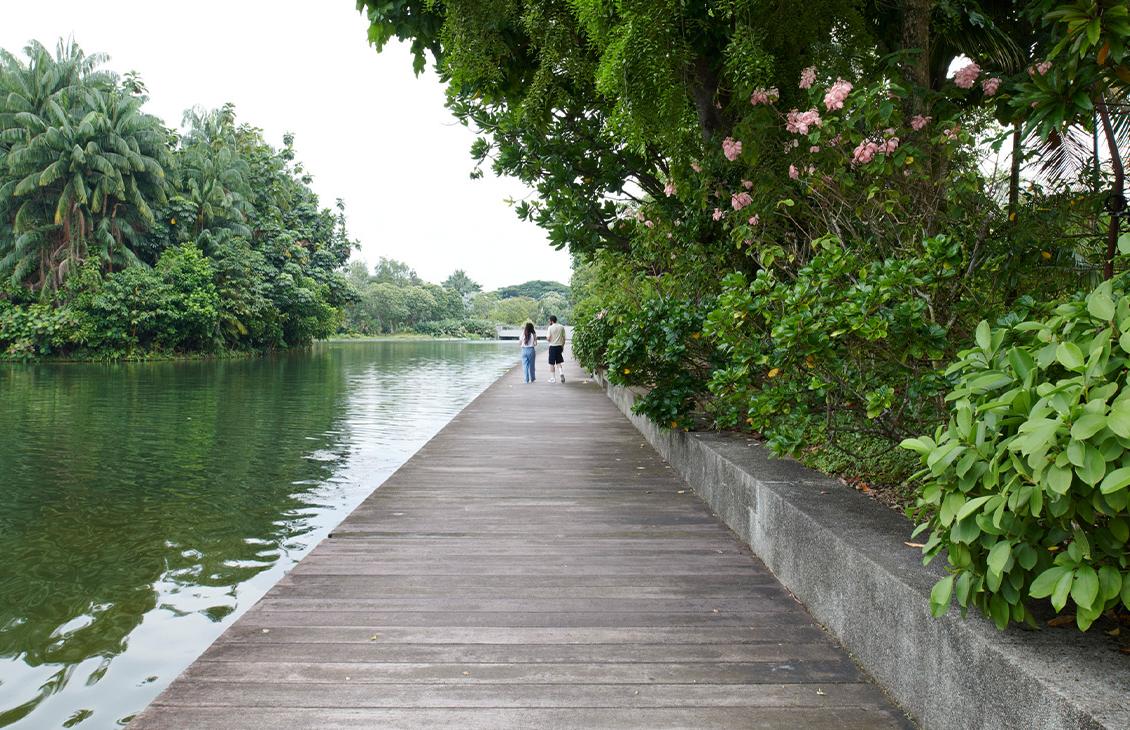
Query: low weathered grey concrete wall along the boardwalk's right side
[{"left": 606, "top": 383, "right": 1130, "bottom": 730}]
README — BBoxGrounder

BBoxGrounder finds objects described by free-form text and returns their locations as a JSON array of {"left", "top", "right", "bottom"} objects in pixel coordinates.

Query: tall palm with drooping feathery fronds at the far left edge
[{"left": 0, "top": 42, "right": 168, "bottom": 290}]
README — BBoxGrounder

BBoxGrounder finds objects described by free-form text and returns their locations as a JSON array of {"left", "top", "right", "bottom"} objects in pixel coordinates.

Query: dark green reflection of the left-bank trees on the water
[{"left": 0, "top": 350, "right": 347, "bottom": 725}]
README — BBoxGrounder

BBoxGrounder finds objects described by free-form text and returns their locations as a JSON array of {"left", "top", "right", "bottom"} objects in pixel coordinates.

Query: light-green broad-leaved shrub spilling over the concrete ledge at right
[{"left": 903, "top": 276, "right": 1130, "bottom": 631}]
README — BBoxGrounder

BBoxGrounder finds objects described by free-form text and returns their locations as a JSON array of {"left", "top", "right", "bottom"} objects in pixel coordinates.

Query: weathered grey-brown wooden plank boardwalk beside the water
[{"left": 130, "top": 357, "right": 914, "bottom": 730}]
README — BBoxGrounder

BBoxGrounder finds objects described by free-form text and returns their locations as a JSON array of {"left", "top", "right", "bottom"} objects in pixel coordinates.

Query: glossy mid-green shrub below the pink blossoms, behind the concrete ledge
[{"left": 705, "top": 236, "right": 961, "bottom": 453}]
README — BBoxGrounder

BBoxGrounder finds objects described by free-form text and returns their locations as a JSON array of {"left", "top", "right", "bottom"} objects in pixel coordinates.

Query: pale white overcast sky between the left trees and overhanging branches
[{"left": 0, "top": 0, "right": 570, "bottom": 289}]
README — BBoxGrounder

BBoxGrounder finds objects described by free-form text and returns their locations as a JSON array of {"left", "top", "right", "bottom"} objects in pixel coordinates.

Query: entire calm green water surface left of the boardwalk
[{"left": 0, "top": 341, "right": 518, "bottom": 728}]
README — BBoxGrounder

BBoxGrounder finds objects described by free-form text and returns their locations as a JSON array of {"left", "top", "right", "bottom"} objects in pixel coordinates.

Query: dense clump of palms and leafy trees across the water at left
[{"left": 0, "top": 42, "right": 355, "bottom": 357}]
